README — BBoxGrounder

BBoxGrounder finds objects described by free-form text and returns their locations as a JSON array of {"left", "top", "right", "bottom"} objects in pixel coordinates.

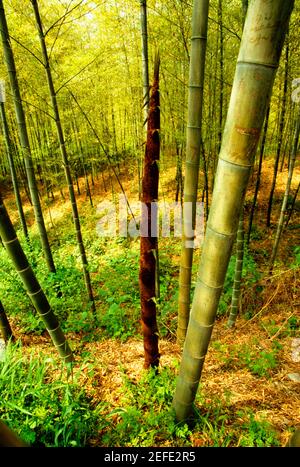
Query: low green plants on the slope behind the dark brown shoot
[{"left": 0, "top": 218, "right": 179, "bottom": 341}]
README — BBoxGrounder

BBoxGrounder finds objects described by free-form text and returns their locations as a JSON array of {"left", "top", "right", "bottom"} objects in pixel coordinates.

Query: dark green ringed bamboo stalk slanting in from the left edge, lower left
[{"left": 0, "top": 193, "right": 74, "bottom": 363}]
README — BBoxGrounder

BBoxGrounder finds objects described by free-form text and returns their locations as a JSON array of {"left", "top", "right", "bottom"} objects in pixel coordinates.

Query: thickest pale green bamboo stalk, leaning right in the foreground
[{"left": 174, "top": 0, "right": 294, "bottom": 420}]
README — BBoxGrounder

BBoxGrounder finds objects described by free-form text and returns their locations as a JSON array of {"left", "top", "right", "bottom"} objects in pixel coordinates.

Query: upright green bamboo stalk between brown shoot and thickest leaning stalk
[{"left": 177, "top": 0, "right": 209, "bottom": 344}]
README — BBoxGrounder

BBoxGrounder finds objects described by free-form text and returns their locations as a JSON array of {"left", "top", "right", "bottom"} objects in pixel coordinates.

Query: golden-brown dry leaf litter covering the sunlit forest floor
[{"left": 2, "top": 156, "right": 300, "bottom": 446}]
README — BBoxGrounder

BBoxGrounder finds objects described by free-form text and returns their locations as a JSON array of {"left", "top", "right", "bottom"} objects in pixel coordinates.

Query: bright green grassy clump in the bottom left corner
[{"left": 0, "top": 346, "right": 99, "bottom": 447}]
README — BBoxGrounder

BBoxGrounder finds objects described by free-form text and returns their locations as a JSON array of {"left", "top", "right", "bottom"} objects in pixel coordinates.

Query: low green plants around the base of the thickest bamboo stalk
[{"left": 101, "top": 362, "right": 279, "bottom": 447}]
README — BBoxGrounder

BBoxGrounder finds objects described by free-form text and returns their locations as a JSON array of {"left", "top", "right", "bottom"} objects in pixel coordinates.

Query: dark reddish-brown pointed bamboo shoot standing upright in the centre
[{"left": 139, "top": 56, "right": 160, "bottom": 368}]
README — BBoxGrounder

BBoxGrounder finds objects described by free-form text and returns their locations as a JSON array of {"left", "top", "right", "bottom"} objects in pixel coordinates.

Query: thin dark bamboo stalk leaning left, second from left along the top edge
[{"left": 31, "top": 0, "right": 96, "bottom": 313}]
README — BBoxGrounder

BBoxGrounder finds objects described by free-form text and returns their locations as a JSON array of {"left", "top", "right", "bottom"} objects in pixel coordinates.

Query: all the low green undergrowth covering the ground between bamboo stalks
[{"left": 0, "top": 192, "right": 299, "bottom": 447}]
